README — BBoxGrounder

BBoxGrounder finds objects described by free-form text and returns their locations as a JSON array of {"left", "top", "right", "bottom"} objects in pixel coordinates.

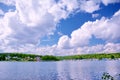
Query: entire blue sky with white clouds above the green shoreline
[{"left": 0, "top": 0, "right": 120, "bottom": 55}]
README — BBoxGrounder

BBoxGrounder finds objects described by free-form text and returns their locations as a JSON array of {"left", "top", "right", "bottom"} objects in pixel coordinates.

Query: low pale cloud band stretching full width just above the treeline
[{"left": 0, "top": 43, "right": 120, "bottom": 56}]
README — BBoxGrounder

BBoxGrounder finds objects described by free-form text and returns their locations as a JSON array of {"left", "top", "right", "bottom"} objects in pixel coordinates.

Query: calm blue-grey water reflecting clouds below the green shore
[{"left": 0, "top": 60, "right": 120, "bottom": 80}]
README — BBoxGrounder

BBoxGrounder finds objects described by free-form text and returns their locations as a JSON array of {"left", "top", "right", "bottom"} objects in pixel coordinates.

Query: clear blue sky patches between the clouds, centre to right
[{"left": 42, "top": 3, "right": 120, "bottom": 45}]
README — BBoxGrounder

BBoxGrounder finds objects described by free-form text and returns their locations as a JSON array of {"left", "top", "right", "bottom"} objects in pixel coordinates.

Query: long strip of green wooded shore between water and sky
[{"left": 0, "top": 53, "right": 120, "bottom": 61}]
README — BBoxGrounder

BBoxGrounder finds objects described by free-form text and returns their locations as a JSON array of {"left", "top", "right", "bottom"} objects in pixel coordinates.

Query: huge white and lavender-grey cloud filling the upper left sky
[{"left": 0, "top": 0, "right": 80, "bottom": 45}]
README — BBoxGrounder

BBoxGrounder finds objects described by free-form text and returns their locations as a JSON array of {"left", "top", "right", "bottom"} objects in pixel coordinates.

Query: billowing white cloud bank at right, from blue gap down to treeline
[{"left": 57, "top": 10, "right": 120, "bottom": 55}]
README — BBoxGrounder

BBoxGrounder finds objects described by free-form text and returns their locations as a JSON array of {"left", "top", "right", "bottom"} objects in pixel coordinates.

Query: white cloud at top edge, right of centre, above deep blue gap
[{"left": 79, "top": 0, "right": 120, "bottom": 13}]
